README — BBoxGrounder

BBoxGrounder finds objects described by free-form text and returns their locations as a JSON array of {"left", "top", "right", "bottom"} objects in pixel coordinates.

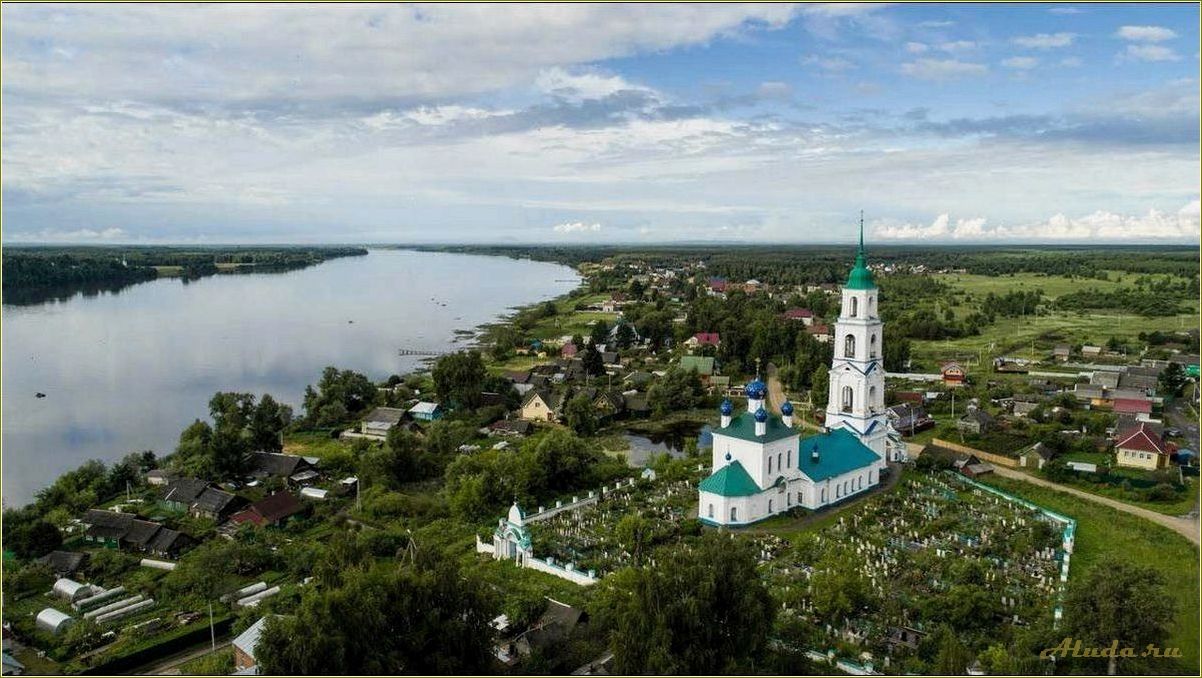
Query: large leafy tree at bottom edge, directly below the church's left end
[{"left": 595, "top": 533, "right": 775, "bottom": 674}]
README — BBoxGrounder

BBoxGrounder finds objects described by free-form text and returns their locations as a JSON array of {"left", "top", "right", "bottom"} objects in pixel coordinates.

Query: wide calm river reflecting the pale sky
[{"left": 2, "top": 250, "right": 578, "bottom": 506}]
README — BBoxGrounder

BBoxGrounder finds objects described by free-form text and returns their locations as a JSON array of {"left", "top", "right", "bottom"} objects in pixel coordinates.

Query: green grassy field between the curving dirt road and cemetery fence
[{"left": 983, "top": 475, "right": 1198, "bottom": 674}]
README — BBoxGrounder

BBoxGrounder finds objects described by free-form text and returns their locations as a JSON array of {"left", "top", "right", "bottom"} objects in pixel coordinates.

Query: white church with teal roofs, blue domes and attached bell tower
[{"left": 697, "top": 222, "right": 895, "bottom": 525}]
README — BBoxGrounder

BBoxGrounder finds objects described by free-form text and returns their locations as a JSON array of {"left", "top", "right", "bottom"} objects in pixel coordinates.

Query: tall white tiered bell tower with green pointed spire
[{"left": 826, "top": 212, "right": 888, "bottom": 459}]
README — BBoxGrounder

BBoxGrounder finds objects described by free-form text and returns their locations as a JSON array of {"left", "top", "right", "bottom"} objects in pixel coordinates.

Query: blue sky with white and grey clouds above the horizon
[{"left": 0, "top": 4, "right": 1202, "bottom": 244}]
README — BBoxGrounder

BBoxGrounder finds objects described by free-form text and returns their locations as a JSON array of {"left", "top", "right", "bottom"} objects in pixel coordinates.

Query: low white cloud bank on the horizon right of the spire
[{"left": 871, "top": 200, "right": 1200, "bottom": 242}]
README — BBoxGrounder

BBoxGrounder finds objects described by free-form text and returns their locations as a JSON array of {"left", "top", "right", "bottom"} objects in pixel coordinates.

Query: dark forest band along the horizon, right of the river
[{"left": 413, "top": 244, "right": 1198, "bottom": 285}]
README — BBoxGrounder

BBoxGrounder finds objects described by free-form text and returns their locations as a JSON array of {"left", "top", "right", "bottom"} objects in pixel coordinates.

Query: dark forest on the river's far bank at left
[{"left": 4, "top": 246, "right": 367, "bottom": 304}]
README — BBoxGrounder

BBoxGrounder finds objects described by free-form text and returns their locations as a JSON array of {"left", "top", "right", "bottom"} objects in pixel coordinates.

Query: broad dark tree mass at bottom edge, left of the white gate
[{"left": 255, "top": 555, "right": 495, "bottom": 676}]
